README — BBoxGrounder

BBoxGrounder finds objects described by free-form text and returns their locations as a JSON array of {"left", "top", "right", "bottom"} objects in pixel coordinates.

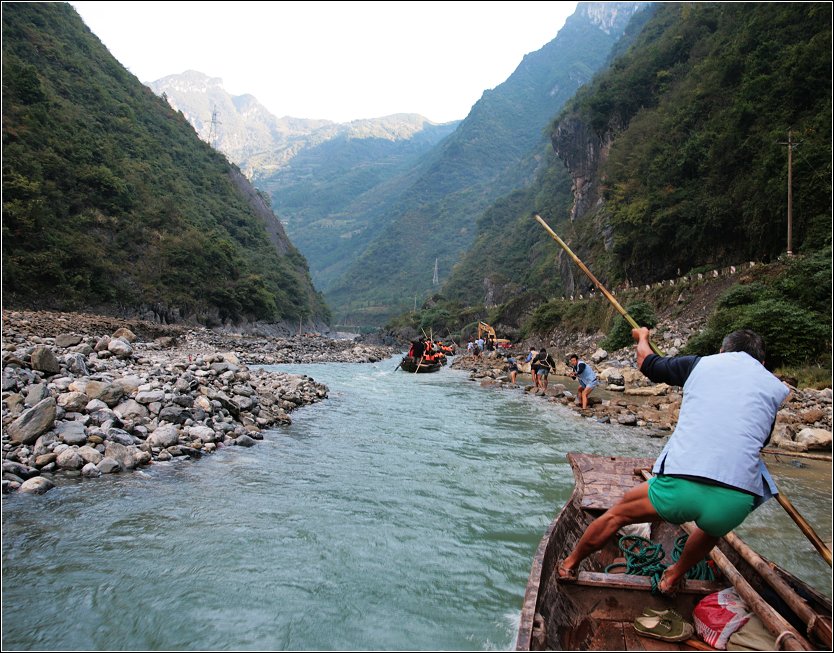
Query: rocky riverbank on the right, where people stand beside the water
[{"left": 452, "top": 337, "right": 832, "bottom": 453}]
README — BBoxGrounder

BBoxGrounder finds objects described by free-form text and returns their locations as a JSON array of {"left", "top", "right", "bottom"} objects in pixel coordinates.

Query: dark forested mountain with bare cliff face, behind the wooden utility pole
[{"left": 443, "top": 3, "right": 832, "bottom": 310}]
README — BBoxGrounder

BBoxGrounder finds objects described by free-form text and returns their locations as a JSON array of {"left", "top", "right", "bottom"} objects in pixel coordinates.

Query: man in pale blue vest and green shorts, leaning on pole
[{"left": 557, "top": 327, "right": 789, "bottom": 596}]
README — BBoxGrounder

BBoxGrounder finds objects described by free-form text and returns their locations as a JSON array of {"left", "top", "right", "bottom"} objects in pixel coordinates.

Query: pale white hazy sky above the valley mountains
[{"left": 70, "top": 1, "right": 577, "bottom": 122}]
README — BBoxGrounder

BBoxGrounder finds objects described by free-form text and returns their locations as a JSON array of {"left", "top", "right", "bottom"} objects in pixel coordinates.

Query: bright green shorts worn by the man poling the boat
[{"left": 649, "top": 476, "right": 753, "bottom": 537}]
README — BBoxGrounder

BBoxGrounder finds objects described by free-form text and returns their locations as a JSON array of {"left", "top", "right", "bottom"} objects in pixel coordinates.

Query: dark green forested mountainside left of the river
[{"left": 2, "top": 3, "right": 329, "bottom": 324}]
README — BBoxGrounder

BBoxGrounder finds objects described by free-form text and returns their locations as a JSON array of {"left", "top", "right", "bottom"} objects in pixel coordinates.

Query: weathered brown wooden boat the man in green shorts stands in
[{"left": 516, "top": 454, "right": 832, "bottom": 651}]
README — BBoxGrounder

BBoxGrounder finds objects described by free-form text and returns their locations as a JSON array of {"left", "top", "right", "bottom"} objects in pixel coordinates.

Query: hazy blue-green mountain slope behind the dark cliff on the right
[{"left": 323, "top": 2, "right": 645, "bottom": 324}]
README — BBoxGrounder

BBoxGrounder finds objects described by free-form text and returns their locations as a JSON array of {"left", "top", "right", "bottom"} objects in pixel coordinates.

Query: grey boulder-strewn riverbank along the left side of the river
[{"left": 2, "top": 311, "right": 394, "bottom": 493}]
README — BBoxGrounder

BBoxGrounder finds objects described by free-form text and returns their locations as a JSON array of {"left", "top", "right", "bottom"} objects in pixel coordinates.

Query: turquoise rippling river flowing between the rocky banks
[{"left": 2, "top": 358, "right": 832, "bottom": 651}]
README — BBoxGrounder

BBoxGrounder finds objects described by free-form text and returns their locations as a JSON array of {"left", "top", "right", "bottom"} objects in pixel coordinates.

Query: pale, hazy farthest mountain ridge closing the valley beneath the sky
[{"left": 149, "top": 71, "right": 458, "bottom": 287}]
